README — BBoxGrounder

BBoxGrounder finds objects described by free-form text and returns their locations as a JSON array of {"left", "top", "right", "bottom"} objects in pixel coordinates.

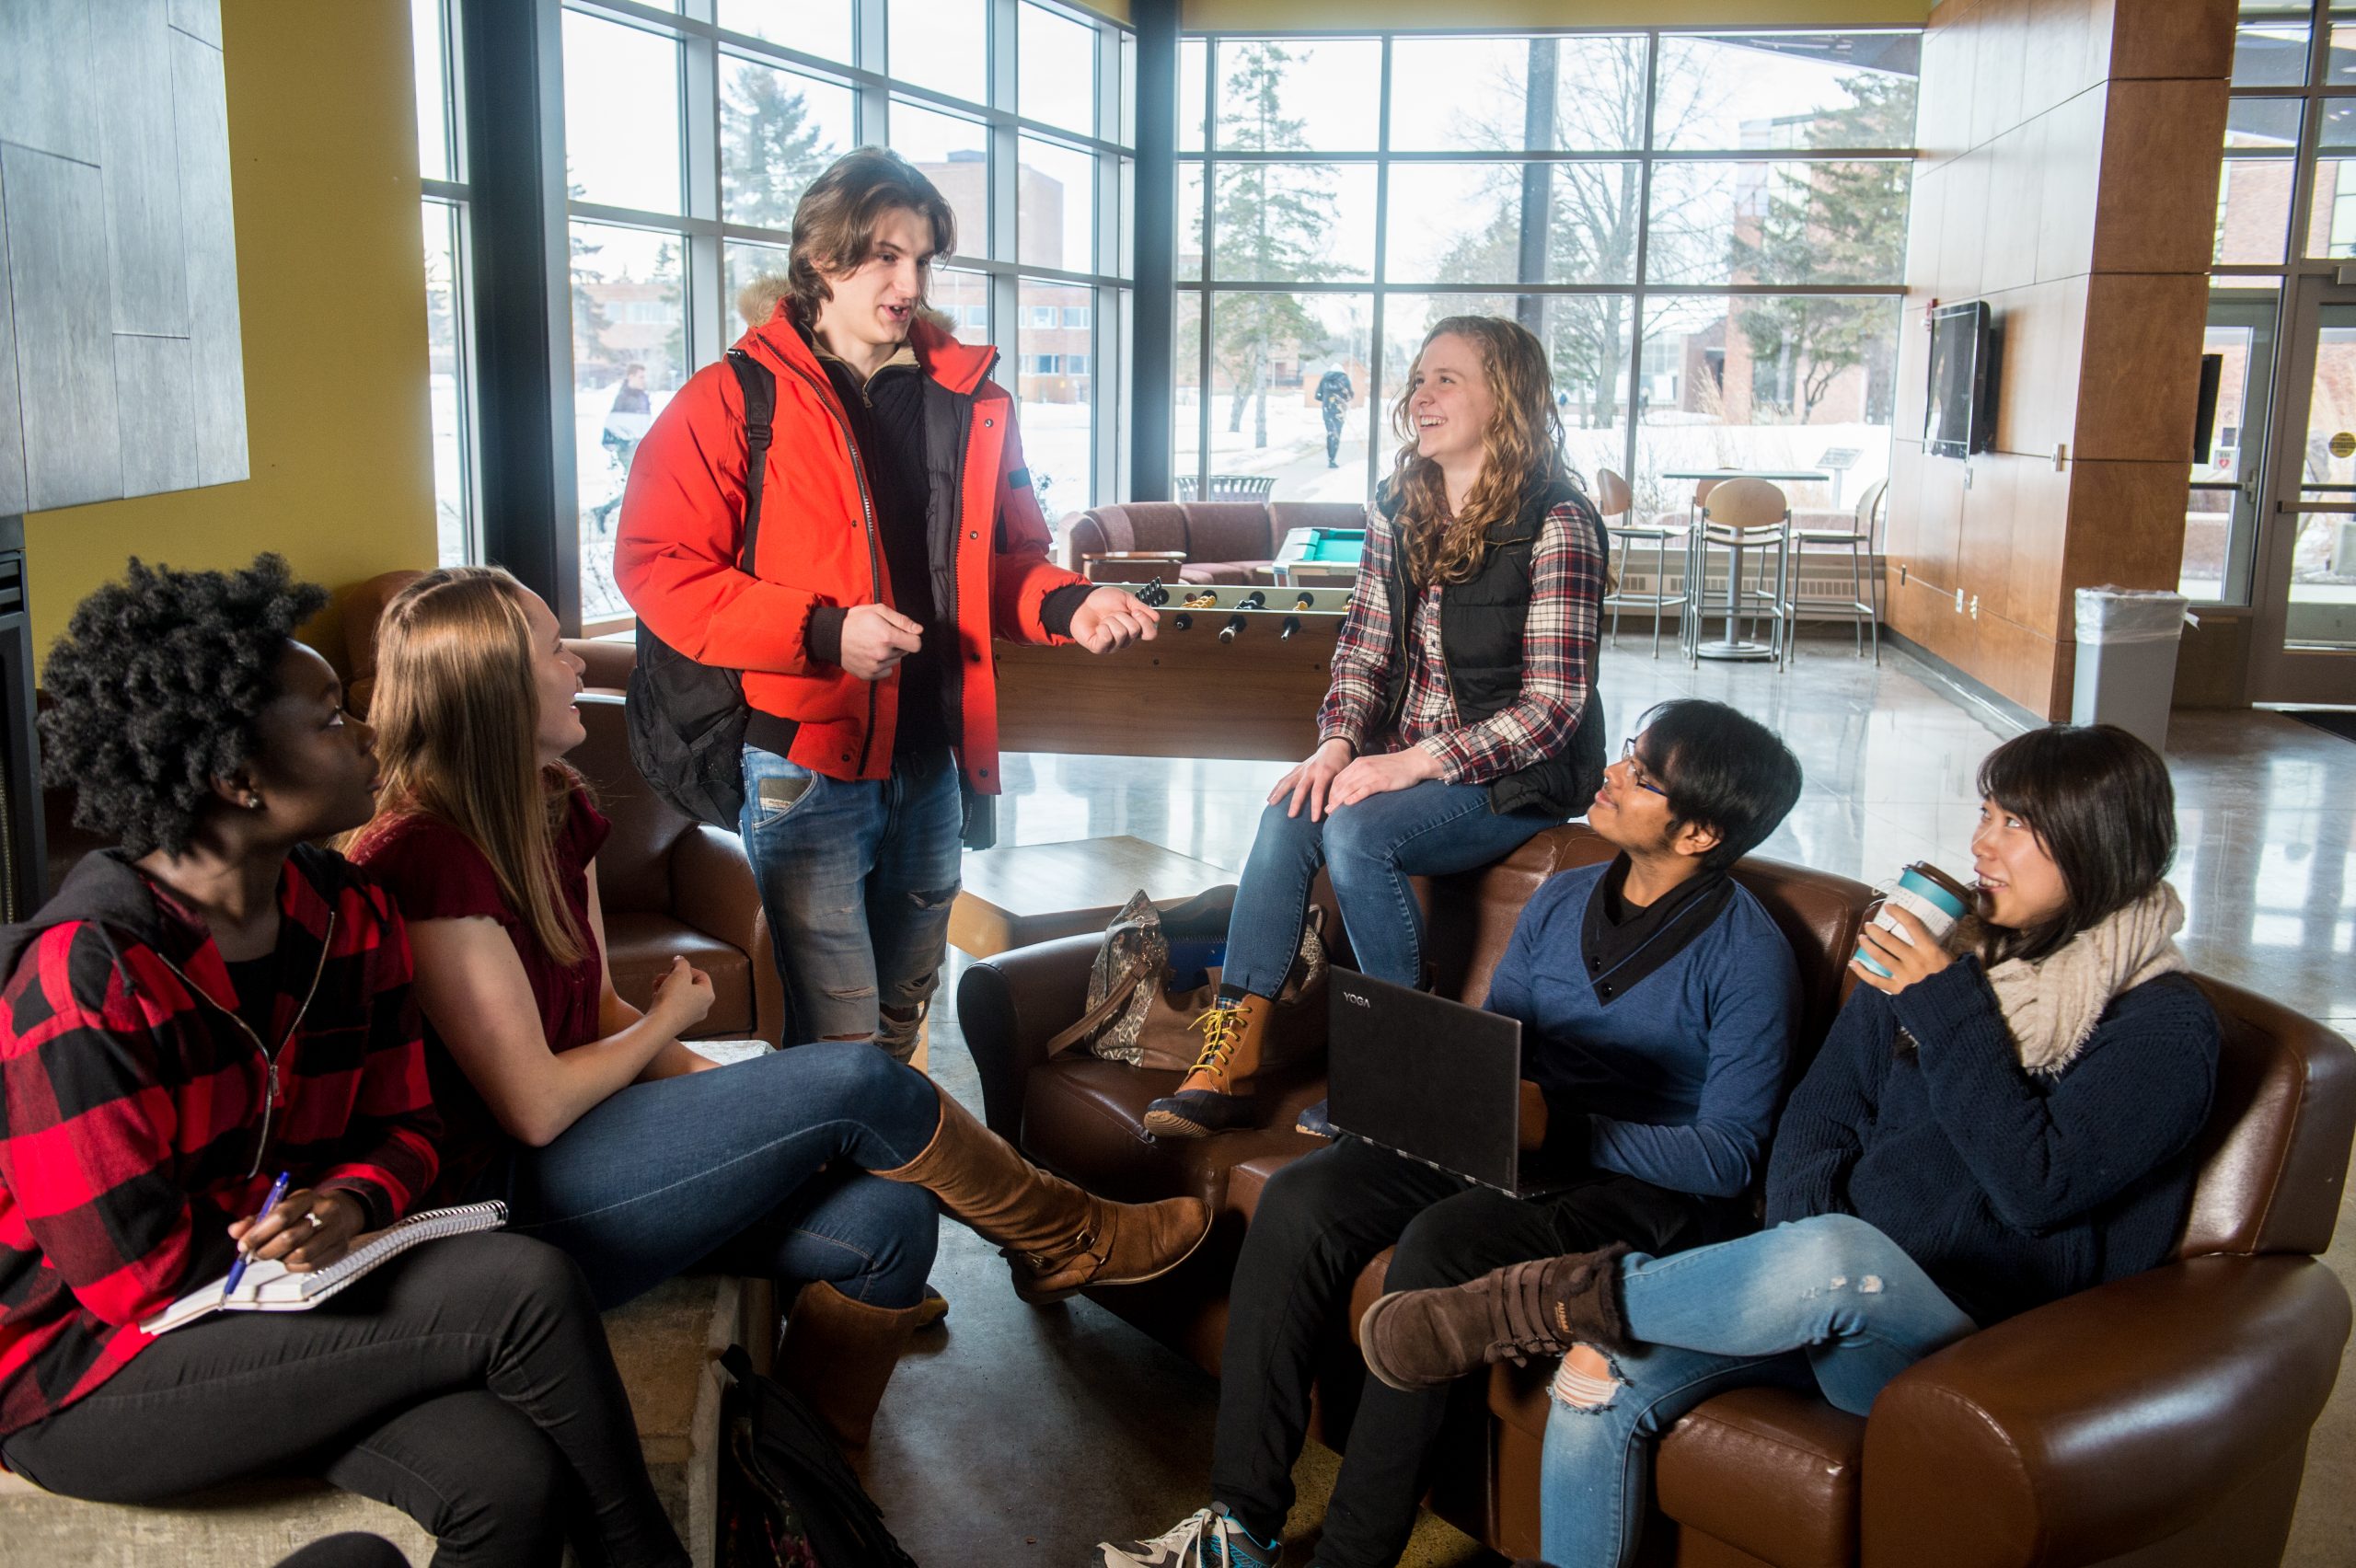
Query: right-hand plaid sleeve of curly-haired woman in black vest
[{"left": 1403, "top": 502, "right": 1604, "bottom": 784}]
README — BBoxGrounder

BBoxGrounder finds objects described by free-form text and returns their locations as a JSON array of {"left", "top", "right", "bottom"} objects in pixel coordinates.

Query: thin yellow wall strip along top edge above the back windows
[{"left": 1178, "top": 0, "right": 1922, "bottom": 33}]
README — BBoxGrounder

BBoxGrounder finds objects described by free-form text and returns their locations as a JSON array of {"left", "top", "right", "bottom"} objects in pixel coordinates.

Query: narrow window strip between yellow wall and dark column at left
[{"left": 410, "top": 0, "right": 483, "bottom": 565}]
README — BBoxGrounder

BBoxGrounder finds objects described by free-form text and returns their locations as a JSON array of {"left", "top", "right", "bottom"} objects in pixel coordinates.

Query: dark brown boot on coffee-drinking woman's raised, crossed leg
[{"left": 1357, "top": 1240, "right": 1628, "bottom": 1394}]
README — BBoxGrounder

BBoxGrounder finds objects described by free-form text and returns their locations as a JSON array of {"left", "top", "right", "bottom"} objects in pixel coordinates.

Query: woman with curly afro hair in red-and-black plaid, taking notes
[{"left": 0, "top": 556, "right": 686, "bottom": 1565}]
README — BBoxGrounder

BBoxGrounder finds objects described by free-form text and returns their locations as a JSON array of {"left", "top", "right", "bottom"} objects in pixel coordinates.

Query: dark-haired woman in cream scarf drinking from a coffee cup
[{"left": 1359, "top": 725, "right": 2217, "bottom": 1568}]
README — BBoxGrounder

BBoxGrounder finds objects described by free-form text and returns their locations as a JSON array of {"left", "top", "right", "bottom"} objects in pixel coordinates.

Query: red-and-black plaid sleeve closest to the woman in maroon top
[{"left": 318, "top": 888, "right": 441, "bottom": 1224}]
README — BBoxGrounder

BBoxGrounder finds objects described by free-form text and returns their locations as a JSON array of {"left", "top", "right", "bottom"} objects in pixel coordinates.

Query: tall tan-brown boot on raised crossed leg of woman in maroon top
[{"left": 874, "top": 1085, "right": 1211, "bottom": 1304}]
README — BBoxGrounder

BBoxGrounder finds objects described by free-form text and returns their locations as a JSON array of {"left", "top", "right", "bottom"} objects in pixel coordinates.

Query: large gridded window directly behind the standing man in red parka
[{"left": 560, "top": 0, "right": 1130, "bottom": 628}]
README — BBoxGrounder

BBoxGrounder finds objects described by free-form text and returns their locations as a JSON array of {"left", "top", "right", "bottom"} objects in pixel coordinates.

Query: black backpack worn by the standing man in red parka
[{"left": 624, "top": 349, "right": 778, "bottom": 834}]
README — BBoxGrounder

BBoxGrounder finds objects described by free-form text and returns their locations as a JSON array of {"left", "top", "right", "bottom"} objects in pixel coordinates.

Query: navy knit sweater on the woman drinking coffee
[{"left": 1767, "top": 958, "right": 2217, "bottom": 1328}]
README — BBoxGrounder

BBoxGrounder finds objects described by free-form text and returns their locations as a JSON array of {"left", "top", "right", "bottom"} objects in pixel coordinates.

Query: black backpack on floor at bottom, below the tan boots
[{"left": 719, "top": 1344, "right": 917, "bottom": 1568}]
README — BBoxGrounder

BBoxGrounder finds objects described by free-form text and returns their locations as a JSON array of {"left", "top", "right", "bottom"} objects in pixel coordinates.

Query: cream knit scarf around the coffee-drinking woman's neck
[{"left": 1946, "top": 882, "right": 2187, "bottom": 1078}]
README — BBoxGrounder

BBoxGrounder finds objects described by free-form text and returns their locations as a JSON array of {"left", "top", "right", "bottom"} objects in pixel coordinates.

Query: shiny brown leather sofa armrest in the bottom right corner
[{"left": 1861, "top": 1255, "right": 2349, "bottom": 1568}]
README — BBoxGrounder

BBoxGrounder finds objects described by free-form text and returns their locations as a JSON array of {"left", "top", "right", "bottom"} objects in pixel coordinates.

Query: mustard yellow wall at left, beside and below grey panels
[{"left": 26, "top": 0, "right": 433, "bottom": 662}]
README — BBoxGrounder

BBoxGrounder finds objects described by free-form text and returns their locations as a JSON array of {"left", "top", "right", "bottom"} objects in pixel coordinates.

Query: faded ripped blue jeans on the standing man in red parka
[{"left": 737, "top": 746, "right": 966, "bottom": 1062}]
